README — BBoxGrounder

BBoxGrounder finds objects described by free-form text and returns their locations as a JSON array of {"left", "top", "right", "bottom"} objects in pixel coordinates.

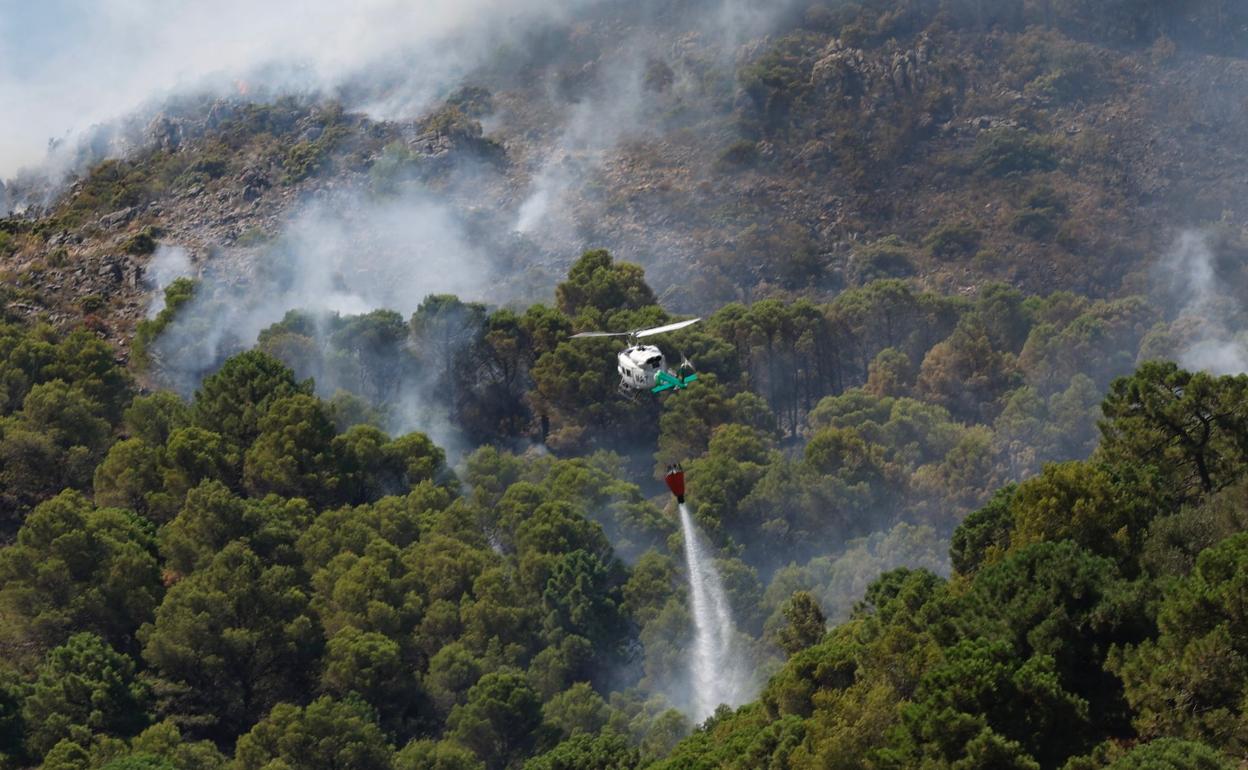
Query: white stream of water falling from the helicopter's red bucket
[{"left": 680, "top": 503, "right": 751, "bottom": 721}]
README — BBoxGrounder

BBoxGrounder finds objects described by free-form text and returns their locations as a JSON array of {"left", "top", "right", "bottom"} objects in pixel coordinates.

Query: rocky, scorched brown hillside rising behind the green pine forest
[{"left": 0, "top": 2, "right": 1248, "bottom": 347}]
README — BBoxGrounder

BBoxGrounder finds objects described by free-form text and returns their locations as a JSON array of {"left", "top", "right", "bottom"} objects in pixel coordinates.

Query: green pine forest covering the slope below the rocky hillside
[{"left": 0, "top": 243, "right": 1248, "bottom": 770}]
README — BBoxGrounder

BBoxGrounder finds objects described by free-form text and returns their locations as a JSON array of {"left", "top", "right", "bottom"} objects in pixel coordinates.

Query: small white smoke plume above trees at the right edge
[{"left": 1157, "top": 231, "right": 1248, "bottom": 374}]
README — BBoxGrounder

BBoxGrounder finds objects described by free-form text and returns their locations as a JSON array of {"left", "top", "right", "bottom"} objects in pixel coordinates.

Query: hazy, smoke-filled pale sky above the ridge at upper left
[{"left": 0, "top": 0, "right": 578, "bottom": 178}]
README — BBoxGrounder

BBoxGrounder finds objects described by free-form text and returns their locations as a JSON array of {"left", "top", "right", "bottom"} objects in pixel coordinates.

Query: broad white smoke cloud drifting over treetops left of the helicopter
[{"left": 154, "top": 183, "right": 507, "bottom": 443}]
